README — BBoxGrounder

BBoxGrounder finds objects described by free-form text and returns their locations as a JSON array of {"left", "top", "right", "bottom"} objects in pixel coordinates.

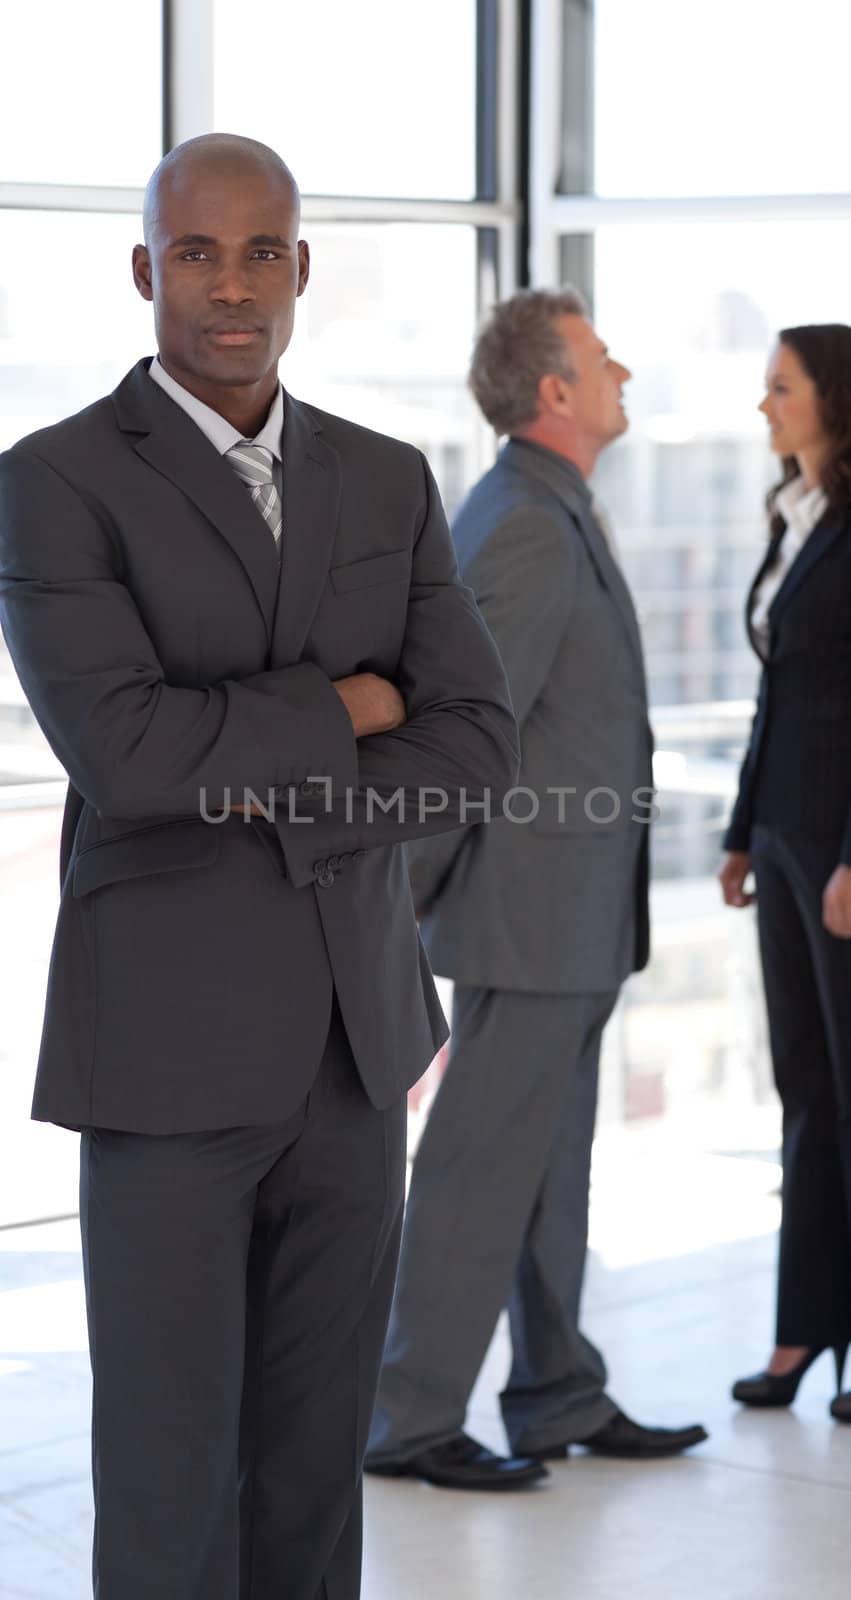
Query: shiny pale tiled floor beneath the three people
[{"left": 0, "top": 1138, "right": 851, "bottom": 1600}]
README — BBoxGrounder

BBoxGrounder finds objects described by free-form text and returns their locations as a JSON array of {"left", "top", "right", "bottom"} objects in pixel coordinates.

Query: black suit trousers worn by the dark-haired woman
[{"left": 752, "top": 827, "right": 851, "bottom": 1346}]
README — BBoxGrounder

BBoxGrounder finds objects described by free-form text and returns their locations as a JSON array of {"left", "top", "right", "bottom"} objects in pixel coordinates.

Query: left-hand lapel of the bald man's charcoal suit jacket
[{"left": 112, "top": 360, "right": 278, "bottom": 638}]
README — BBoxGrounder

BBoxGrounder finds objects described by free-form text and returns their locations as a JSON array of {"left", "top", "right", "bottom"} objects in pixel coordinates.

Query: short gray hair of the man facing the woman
[{"left": 469, "top": 285, "right": 589, "bottom": 434}]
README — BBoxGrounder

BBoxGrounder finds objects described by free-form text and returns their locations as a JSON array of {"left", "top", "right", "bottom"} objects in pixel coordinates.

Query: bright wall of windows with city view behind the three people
[{"left": 0, "top": 0, "right": 851, "bottom": 1221}]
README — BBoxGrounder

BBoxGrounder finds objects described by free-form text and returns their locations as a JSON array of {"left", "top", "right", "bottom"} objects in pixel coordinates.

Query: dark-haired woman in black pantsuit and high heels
[{"left": 720, "top": 323, "right": 851, "bottom": 1422}]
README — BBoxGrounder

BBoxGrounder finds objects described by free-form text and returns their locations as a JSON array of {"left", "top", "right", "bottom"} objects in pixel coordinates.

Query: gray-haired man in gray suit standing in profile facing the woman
[{"left": 368, "top": 290, "right": 705, "bottom": 1488}]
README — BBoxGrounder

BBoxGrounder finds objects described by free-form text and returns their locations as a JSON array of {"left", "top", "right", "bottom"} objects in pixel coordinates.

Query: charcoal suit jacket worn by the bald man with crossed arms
[{"left": 0, "top": 360, "right": 517, "bottom": 1133}]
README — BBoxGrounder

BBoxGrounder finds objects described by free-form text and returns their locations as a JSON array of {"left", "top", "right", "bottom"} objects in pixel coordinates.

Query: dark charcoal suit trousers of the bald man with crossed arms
[{"left": 80, "top": 1005, "right": 405, "bottom": 1600}]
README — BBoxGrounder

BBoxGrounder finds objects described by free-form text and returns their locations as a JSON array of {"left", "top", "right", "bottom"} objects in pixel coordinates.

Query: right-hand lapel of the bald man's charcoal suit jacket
[{"left": 272, "top": 395, "right": 339, "bottom": 666}]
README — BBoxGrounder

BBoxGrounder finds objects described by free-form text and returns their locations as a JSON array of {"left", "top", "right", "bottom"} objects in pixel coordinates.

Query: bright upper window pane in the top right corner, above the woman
[{"left": 595, "top": 0, "right": 851, "bottom": 197}]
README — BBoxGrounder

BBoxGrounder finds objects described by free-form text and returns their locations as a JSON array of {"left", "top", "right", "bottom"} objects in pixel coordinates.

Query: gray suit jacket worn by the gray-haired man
[{"left": 406, "top": 440, "right": 653, "bottom": 994}]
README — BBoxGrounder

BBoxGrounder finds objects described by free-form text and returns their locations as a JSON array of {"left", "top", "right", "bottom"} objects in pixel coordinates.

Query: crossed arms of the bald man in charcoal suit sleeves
[{"left": 0, "top": 446, "right": 518, "bottom": 883}]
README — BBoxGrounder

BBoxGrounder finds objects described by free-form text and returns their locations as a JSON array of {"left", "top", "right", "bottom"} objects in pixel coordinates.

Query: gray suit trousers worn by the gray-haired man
[{"left": 370, "top": 987, "right": 617, "bottom": 1464}]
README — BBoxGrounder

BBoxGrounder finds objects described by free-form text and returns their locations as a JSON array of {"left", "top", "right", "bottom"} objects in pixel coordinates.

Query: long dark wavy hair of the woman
[{"left": 766, "top": 322, "right": 851, "bottom": 533}]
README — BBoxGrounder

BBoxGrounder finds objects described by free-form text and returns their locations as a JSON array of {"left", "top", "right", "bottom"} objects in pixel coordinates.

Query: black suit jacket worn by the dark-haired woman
[{"left": 725, "top": 512, "right": 851, "bottom": 866}]
